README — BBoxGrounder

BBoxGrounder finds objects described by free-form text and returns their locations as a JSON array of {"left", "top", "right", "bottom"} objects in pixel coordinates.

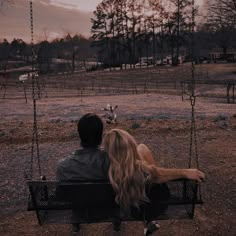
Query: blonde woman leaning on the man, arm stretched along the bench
[{"left": 104, "top": 129, "right": 205, "bottom": 209}]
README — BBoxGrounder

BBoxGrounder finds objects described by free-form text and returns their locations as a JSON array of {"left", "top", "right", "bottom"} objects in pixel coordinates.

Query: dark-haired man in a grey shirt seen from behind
[{"left": 56, "top": 113, "right": 110, "bottom": 181}]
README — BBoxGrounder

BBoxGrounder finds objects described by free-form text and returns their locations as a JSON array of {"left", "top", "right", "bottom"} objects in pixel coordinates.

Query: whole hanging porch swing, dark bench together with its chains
[{"left": 25, "top": 1, "right": 203, "bottom": 229}]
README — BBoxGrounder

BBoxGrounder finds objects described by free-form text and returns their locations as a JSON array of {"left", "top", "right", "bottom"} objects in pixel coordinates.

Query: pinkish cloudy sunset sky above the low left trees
[{"left": 0, "top": 0, "right": 203, "bottom": 42}]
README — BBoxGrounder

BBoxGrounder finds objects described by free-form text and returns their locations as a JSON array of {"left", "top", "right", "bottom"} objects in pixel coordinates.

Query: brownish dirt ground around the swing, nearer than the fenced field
[{"left": 0, "top": 63, "right": 236, "bottom": 236}]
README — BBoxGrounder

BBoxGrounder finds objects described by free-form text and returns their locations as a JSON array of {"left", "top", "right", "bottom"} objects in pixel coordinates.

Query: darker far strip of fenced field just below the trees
[{"left": 0, "top": 64, "right": 236, "bottom": 100}]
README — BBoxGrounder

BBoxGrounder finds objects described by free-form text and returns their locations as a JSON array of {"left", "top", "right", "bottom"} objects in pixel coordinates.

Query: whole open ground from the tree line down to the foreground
[{"left": 0, "top": 64, "right": 236, "bottom": 236}]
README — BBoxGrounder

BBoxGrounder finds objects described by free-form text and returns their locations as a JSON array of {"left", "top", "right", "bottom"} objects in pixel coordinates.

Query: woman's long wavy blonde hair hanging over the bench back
[{"left": 104, "top": 129, "right": 147, "bottom": 209}]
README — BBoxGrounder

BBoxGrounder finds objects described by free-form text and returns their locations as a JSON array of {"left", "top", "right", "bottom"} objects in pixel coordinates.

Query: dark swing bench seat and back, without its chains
[{"left": 27, "top": 179, "right": 203, "bottom": 225}]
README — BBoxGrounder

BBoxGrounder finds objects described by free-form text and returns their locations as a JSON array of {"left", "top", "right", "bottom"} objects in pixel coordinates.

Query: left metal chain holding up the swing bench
[{"left": 29, "top": 1, "right": 41, "bottom": 179}]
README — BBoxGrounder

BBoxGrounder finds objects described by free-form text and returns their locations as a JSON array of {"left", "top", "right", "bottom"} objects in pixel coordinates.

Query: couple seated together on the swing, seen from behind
[{"left": 56, "top": 113, "right": 205, "bottom": 233}]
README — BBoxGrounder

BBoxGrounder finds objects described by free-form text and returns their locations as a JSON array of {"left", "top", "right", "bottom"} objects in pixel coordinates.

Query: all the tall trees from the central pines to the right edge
[{"left": 91, "top": 0, "right": 236, "bottom": 66}]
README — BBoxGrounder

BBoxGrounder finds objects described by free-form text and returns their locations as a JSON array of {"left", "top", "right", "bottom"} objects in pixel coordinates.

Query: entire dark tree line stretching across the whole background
[{"left": 0, "top": 0, "right": 236, "bottom": 72}]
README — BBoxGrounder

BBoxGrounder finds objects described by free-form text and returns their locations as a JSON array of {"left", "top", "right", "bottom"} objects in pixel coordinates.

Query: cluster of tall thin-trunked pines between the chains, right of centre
[{"left": 91, "top": 0, "right": 196, "bottom": 65}]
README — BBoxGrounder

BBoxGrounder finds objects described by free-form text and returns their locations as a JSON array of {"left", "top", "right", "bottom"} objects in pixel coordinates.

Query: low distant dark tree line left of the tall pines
[{"left": 0, "top": 34, "right": 96, "bottom": 73}]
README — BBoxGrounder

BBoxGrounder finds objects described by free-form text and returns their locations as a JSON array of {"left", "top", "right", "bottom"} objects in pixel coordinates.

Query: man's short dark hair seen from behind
[{"left": 78, "top": 113, "right": 103, "bottom": 148}]
